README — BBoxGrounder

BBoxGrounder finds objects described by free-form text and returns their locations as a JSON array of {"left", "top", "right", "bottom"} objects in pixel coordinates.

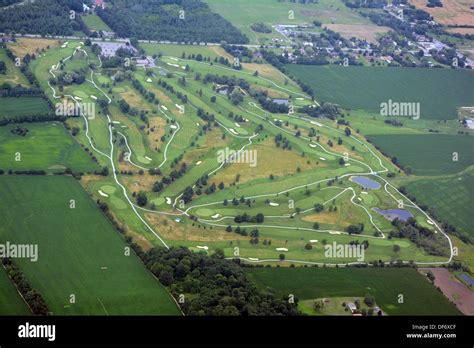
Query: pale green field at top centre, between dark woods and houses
[{"left": 205, "top": 0, "right": 369, "bottom": 44}]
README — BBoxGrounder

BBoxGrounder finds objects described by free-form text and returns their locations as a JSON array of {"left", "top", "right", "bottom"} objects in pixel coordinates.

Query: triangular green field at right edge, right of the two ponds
[{"left": 406, "top": 170, "right": 474, "bottom": 237}]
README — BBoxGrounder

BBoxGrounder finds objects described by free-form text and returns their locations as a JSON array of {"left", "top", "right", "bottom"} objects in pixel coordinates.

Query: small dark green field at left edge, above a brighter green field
[{"left": 0, "top": 97, "right": 53, "bottom": 119}]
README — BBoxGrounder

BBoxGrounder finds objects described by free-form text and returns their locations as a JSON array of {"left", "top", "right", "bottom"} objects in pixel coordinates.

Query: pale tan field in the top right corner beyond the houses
[{"left": 410, "top": 0, "right": 474, "bottom": 25}]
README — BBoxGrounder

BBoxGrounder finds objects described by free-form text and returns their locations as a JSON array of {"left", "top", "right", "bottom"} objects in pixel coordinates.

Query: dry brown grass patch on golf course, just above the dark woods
[{"left": 145, "top": 213, "right": 244, "bottom": 242}]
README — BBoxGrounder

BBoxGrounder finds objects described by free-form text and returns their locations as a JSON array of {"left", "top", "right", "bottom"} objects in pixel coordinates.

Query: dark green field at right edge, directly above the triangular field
[{"left": 368, "top": 134, "right": 474, "bottom": 175}]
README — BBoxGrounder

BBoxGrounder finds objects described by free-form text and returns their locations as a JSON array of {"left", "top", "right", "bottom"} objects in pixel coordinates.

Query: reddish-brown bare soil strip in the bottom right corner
[{"left": 420, "top": 268, "right": 474, "bottom": 315}]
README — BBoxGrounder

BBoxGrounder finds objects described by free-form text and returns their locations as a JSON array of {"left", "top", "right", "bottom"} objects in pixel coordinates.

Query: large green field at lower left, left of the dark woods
[{"left": 0, "top": 176, "right": 179, "bottom": 315}]
